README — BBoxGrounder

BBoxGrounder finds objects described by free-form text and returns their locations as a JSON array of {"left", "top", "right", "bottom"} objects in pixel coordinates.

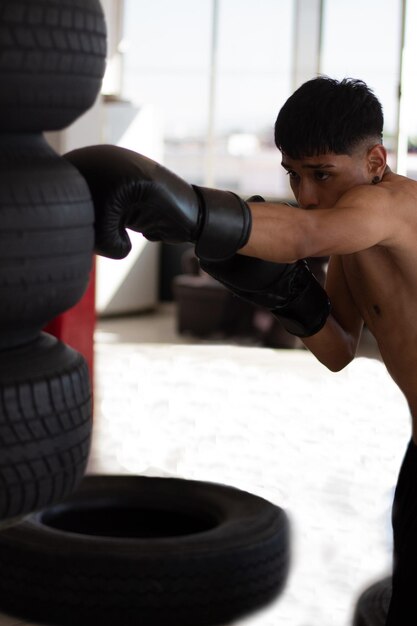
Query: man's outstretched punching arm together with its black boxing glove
[{"left": 65, "top": 145, "right": 392, "bottom": 263}]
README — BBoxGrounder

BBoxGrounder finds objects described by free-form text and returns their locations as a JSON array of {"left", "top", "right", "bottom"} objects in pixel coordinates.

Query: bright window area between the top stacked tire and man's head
[{"left": 119, "top": 0, "right": 294, "bottom": 196}]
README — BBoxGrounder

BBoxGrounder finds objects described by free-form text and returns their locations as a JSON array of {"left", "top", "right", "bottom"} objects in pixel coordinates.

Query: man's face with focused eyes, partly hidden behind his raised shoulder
[{"left": 282, "top": 151, "right": 369, "bottom": 209}]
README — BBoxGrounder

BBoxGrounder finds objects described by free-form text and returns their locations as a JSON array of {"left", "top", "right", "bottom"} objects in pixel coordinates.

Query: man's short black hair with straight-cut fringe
[{"left": 275, "top": 76, "right": 384, "bottom": 159}]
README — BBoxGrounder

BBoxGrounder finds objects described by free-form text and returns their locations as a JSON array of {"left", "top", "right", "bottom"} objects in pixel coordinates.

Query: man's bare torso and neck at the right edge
[{"left": 342, "top": 172, "right": 417, "bottom": 416}]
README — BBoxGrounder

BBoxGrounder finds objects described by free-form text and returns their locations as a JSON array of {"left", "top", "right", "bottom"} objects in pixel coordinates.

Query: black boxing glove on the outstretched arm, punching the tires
[{"left": 65, "top": 145, "right": 252, "bottom": 261}]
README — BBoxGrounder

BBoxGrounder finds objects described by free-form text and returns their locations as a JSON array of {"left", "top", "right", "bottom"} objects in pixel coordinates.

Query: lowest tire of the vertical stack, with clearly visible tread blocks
[{"left": 0, "top": 333, "right": 92, "bottom": 520}]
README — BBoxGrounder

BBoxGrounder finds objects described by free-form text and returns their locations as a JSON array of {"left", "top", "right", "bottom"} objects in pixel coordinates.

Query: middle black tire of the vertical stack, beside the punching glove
[{"left": 0, "top": 134, "right": 94, "bottom": 349}]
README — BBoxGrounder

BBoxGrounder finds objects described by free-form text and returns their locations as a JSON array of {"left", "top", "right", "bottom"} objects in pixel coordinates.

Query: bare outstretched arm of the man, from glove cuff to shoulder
[{"left": 239, "top": 185, "right": 395, "bottom": 263}]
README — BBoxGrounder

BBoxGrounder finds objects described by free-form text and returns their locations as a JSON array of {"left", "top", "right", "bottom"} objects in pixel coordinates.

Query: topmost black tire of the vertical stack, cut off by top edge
[{"left": 0, "top": 0, "right": 106, "bottom": 132}]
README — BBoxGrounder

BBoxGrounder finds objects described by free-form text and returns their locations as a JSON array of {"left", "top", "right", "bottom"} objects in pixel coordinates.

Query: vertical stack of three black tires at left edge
[{"left": 0, "top": 0, "right": 106, "bottom": 527}]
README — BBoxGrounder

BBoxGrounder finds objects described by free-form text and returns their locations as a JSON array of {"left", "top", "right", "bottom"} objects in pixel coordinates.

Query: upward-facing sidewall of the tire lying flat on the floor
[{"left": 4, "top": 476, "right": 285, "bottom": 560}]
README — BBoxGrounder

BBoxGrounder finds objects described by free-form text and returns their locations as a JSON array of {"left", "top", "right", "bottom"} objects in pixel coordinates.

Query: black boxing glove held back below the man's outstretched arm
[{"left": 200, "top": 196, "right": 330, "bottom": 337}]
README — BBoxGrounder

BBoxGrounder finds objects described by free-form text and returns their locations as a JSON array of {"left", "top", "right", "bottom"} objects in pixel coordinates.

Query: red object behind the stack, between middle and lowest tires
[{"left": 44, "top": 262, "right": 96, "bottom": 383}]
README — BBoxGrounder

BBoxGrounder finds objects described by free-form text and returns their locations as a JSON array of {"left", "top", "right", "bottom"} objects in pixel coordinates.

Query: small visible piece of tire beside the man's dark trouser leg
[{"left": 353, "top": 576, "right": 392, "bottom": 626}]
